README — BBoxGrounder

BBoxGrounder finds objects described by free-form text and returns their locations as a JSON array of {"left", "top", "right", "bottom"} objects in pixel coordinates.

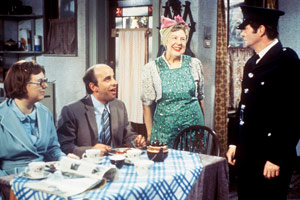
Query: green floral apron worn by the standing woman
[{"left": 151, "top": 55, "right": 204, "bottom": 148}]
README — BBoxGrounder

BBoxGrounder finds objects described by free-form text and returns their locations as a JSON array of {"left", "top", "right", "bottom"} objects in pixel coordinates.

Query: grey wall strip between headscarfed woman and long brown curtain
[{"left": 161, "top": 0, "right": 217, "bottom": 128}]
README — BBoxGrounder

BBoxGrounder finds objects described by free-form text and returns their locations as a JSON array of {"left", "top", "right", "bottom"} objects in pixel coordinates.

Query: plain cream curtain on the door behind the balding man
[{"left": 117, "top": 29, "right": 148, "bottom": 124}]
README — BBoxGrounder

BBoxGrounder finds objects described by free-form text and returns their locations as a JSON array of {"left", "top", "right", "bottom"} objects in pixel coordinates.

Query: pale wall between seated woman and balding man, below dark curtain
[{"left": 37, "top": 0, "right": 87, "bottom": 120}]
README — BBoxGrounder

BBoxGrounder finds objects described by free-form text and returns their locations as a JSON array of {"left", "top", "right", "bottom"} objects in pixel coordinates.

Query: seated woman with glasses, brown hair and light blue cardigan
[{"left": 0, "top": 61, "right": 72, "bottom": 176}]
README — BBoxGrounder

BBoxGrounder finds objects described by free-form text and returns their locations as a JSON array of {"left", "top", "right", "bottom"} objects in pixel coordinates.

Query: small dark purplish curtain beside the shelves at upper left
[{"left": 47, "top": 18, "right": 77, "bottom": 54}]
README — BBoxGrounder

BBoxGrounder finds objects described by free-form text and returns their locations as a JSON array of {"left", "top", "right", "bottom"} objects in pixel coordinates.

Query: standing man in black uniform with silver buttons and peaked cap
[{"left": 226, "top": 5, "right": 300, "bottom": 200}]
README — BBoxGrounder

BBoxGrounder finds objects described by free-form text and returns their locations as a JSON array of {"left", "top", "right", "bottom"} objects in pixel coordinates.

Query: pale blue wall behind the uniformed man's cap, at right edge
[{"left": 278, "top": 0, "right": 300, "bottom": 56}]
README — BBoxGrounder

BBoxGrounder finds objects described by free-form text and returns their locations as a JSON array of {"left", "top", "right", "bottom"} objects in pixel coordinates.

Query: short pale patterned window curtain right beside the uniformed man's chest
[{"left": 228, "top": 48, "right": 253, "bottom": 110}]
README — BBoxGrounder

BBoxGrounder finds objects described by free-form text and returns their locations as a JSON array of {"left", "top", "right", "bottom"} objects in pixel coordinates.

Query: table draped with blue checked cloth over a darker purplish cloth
[{"left": 2, "top": 149, "right": 229, "bottom": 200}]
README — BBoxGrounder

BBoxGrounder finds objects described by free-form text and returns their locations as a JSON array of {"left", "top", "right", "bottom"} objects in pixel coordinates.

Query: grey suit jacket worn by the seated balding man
[{"left": 57, "top": 95, "right": 137, "bottom": 156}]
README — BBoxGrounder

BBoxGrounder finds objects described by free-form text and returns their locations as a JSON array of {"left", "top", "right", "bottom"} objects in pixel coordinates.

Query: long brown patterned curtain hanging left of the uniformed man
[{"left": 214, "top": 0, "right": 229, "bottom": 156}]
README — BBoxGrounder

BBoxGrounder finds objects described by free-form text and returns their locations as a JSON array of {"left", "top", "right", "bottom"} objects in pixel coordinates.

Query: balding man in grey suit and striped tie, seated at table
[{"left": 57, "top": 64, "right": 146, "bottom": 156}]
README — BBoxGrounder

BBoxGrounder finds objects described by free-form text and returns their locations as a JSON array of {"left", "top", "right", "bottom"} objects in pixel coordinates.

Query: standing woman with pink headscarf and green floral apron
[{"left": 141, "top": 15, "right": 204, "bottom": 147}]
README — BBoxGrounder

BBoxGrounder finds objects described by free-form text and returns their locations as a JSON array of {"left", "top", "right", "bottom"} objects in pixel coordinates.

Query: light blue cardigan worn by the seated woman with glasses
[{"left": 0, "top": 100, "right": 65, "bottom": 176}]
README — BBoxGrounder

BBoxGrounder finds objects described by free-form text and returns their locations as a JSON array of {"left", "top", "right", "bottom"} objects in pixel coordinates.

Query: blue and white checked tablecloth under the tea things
[{"left": 11, "top": 149, "right": 202, "bottom": 200}]
